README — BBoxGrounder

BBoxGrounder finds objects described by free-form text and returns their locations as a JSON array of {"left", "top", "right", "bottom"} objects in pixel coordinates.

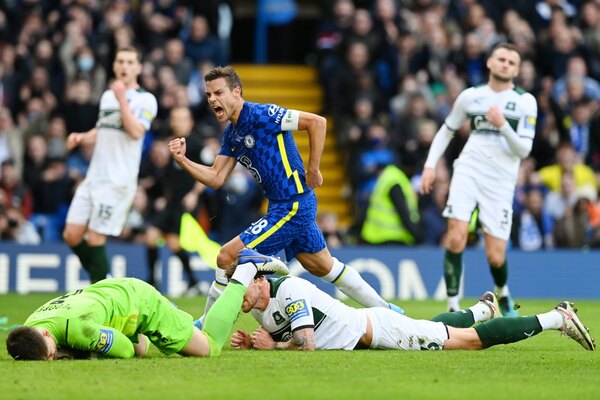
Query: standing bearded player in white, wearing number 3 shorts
[{"left": 420, "top": 44, "right": 537, "bottom": 316}]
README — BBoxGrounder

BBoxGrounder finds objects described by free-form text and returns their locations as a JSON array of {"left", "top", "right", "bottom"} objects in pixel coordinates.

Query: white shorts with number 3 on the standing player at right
[{"left": 443, "top": 170, "right": 515, "bottom": 240}]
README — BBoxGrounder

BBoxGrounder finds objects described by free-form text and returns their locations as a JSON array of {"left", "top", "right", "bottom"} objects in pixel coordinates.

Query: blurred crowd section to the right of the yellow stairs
[{"left": 316, "top": 0, "right": 600, "bottom": 250}]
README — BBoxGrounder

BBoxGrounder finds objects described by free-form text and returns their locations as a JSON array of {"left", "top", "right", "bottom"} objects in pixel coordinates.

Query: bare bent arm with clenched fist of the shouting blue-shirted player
[{"left": 169, "top": 138, "right": 237, "bottom": 189}]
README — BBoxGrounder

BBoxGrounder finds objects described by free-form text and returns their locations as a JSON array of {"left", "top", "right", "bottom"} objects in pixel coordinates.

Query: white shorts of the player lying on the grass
[{"left": 365, "top": 307, "right": 448, "bottom": 350}]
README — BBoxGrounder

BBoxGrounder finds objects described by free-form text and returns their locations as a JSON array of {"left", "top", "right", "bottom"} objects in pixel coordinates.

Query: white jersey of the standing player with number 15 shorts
[{"left": 86, "top": 89, "right": 158, "bottom": 186}]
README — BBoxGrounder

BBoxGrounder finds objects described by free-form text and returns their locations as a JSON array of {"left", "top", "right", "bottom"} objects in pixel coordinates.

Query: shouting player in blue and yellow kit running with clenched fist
[{"left": 169, "top": 66, "right": 403, "bottom": 324}]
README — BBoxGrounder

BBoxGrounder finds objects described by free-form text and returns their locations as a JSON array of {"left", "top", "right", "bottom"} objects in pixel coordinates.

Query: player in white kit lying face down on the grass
[{"left": 231, "top": 276, "right": 594, "bottom": 350}]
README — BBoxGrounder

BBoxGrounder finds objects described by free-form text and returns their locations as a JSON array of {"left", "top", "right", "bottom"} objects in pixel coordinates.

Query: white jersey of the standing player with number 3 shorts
[{"left": 446, "top": 84, "right": 537, "bottom": 182}]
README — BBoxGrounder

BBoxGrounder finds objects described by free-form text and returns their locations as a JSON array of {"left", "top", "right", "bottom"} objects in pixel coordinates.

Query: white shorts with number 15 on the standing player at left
[{"left": 67, "top": 179, "right": 137, "bottom": 236}]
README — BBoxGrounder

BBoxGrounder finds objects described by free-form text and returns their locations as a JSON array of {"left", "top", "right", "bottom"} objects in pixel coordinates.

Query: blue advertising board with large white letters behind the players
[{"left": 0, "top": 242, "right": 600, "bottom": 299}]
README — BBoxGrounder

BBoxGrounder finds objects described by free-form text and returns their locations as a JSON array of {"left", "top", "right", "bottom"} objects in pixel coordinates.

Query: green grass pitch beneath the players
[{"left": 0, "top": 294, "right": 600, "bottom": 400}]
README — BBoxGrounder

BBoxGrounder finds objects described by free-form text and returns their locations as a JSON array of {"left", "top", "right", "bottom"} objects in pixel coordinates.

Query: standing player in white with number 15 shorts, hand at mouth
[{"left": 63, "top": 47, "right": 158, "bottom": 283}]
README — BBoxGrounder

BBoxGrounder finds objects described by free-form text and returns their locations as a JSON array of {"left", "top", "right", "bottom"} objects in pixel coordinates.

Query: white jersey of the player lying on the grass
[{"left": 251, "top": 276, "right": 367, "bottom": 350}]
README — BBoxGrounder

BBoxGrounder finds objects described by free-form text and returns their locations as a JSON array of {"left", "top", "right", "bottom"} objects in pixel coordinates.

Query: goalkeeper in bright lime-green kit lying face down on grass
[{"left": 6, "top": 249, "right": 289, "bottom": 360}]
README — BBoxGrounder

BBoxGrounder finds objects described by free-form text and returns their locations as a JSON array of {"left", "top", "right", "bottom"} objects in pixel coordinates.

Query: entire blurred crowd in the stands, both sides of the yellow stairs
[{"left": 0, "top": 0, "right": 600, "bottom": 250}]
